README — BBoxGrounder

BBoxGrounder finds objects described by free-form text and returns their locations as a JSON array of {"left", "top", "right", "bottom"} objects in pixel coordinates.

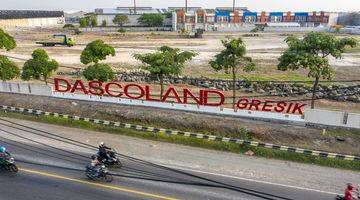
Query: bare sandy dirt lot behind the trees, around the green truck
[{"left": 2, "top": 30, "right": 360, "bottom": 80}]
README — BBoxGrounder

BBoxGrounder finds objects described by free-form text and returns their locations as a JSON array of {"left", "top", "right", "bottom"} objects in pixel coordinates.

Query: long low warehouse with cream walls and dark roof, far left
[{"left": 0, "top": 10, "right": 65, "bottom": 28}]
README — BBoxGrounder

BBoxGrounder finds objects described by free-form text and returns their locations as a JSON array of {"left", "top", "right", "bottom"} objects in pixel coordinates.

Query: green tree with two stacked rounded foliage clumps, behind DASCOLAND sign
[{"left": 80, "top": 40, "right": 115, "bottom": 82}]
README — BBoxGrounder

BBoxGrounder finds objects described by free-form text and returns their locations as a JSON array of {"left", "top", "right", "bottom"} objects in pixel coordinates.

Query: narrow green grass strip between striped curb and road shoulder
[{"left": 0, "top": 111, "right": 360, "bottom": 171}]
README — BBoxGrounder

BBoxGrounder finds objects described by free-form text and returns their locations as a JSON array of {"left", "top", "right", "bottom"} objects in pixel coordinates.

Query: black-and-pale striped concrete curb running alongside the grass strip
[{"left": 1, "top": 106, "right": 360, "bottom": 161}]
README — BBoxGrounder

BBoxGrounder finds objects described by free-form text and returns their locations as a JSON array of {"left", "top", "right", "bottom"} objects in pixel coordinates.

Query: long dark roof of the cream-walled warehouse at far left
[{"left": 0, "top": 10, "right": 64, "bottom": 19}]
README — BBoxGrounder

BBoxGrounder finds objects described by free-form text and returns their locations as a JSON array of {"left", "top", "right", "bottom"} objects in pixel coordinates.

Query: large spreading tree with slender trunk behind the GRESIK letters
[{"left": 278, "top": 32, "right": 357, "bottom": 109}]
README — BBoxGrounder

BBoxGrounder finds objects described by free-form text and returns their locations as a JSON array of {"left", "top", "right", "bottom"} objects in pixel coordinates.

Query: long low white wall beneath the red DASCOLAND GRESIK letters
[{"left": 0, "top": 82, "right": 360, "bottom": 129}]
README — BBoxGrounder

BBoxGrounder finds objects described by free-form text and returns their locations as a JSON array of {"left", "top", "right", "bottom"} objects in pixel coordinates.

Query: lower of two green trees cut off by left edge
[{"left": 0, "top": 55, "right": 20, "bottom": 81}]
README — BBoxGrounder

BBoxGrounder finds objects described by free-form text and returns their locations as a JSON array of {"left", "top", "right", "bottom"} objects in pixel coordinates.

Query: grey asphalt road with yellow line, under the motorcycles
[{"left": 0, "top": 118, "right": 334, "bottom": 200}]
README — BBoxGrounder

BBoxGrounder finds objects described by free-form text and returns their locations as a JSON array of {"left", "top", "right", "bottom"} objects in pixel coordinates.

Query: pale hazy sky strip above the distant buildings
[{"left": 0, "top": 0, "right": 360, "bottom": 11}]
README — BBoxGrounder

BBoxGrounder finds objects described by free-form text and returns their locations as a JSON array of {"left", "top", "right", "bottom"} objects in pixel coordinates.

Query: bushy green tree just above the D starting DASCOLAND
[{"left": 21, "top": 49, "right": 59, "bottom": 84}]
